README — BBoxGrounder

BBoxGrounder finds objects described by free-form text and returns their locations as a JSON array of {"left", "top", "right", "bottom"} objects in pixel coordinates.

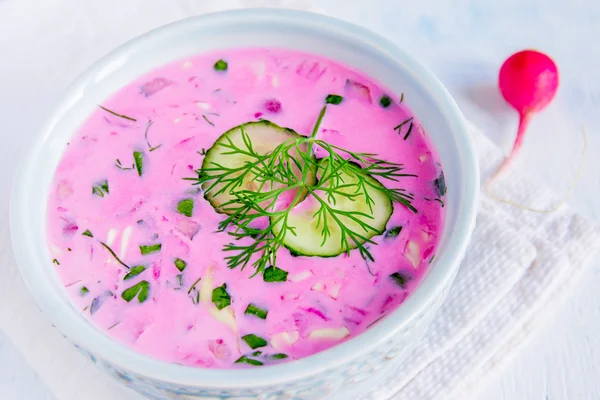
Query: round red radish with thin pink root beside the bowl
[{"left": 496, "top": 50, "right": 558, "bottom": 175}]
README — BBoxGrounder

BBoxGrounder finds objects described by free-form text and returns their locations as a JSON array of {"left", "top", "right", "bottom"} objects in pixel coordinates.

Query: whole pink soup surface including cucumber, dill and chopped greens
[{"left": 47, "top": 49, "right": 446, "bottom": 368}]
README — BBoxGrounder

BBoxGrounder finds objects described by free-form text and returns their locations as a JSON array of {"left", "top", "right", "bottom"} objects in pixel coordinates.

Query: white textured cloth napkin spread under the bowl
[{"left": 0, "top": 122, "right": 600, "bottom": 400}]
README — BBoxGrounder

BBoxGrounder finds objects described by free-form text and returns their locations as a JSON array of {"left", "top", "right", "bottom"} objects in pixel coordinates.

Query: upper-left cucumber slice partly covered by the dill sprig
[{"left": 202, "top": 120, "right": 316, "bottom": 214}]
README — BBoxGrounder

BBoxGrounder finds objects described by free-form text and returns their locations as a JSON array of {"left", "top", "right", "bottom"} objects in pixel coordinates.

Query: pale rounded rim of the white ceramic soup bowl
[{"left": 10, "top": 8, "right": 479, "bottom": 389}]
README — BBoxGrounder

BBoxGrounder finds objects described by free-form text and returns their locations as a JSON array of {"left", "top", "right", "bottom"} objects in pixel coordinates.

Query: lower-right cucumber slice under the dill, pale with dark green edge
[{"left": 272, "top": 160, "right": 393, "bottom": 257}]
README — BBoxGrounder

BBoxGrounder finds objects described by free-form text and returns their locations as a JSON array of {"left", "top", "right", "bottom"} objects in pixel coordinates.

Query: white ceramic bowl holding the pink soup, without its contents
[{"left": 11, "top": 9, "right": 479, "bottom": 399}]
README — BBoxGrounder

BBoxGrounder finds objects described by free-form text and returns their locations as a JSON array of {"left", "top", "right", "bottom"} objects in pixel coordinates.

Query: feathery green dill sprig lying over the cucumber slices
[{"left": 187, "top": 105, "right": 417, "bottom": 281}]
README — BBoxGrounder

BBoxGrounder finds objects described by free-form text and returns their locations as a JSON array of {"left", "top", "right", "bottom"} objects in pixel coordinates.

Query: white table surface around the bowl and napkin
[{"left": 0, "top": 0, "right": 600, "bottom": 400}]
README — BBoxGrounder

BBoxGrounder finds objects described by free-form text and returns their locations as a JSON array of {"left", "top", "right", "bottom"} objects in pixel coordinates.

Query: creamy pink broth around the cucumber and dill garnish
[{"left": 47, "top": 49, "right": 444, "bottom": 368}]
